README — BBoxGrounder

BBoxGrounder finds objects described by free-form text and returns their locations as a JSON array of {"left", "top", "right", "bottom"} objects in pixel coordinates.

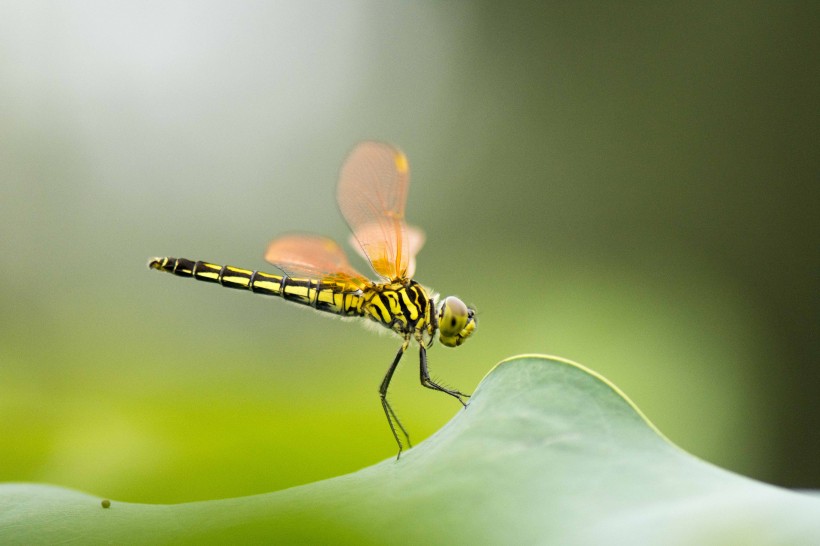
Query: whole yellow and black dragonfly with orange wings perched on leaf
[{"left": 148, "top": 141, "right": 478, "bottom": 454}]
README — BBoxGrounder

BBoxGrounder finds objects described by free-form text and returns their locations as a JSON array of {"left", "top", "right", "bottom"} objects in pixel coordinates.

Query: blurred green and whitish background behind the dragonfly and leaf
[{"left": 0, "top": 1, "right": 820, "bottom": 502}]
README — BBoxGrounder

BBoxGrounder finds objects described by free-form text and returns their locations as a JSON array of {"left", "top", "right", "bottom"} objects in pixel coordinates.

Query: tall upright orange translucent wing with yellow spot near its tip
[{"left": 336, "top": 142, "right": 423, "bottom": 280}]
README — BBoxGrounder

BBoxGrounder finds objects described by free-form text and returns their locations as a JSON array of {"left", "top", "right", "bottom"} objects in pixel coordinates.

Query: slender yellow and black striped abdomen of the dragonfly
[{"left": 148, "top": 258, "right": 364, "bottom": 316}]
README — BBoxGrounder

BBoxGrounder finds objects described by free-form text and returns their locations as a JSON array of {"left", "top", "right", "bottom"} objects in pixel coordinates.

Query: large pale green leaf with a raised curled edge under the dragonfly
[{"left": 0, "top": 356, "right": 820, "bottom": 545}]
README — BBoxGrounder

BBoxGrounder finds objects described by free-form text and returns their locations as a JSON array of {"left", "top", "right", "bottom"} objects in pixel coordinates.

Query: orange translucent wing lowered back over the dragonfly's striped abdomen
[{"left": 265, "top": 234, "right": 370, "bottom": 288}]
